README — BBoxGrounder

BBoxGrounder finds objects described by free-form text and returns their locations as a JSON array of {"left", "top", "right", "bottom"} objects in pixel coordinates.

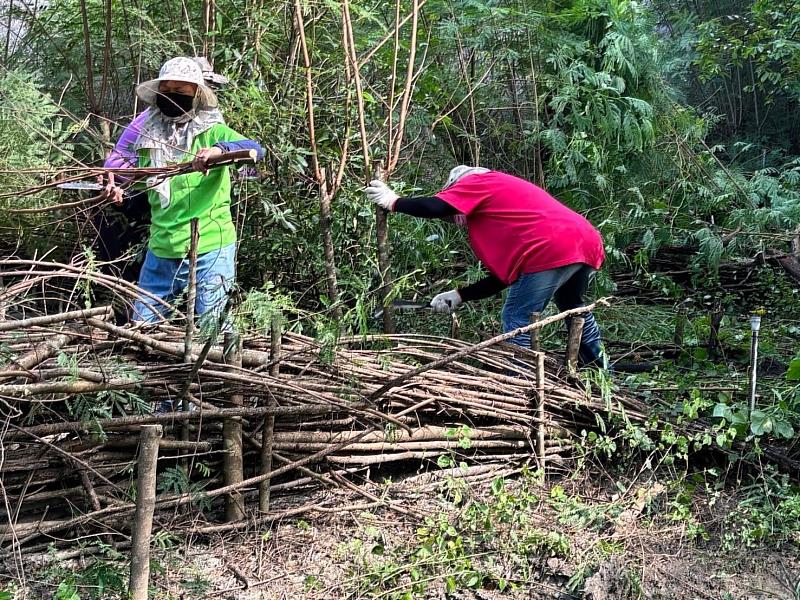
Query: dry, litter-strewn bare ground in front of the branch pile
[{"left": 114, "top": 472, "right": 800, "bottom": 600}]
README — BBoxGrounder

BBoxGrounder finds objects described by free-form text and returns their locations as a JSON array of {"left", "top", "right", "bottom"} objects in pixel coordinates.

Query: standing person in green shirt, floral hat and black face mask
[{"left": 103, "top": 57, "right": 264, "bottom": 322}]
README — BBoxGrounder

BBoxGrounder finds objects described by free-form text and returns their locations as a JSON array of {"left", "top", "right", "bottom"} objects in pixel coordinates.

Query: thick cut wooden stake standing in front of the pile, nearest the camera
[{"left": 128, "top": 425, "right": 162, "bottom": 600}]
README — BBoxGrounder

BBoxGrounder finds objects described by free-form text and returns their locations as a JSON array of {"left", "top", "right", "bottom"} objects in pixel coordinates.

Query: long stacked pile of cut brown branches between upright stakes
[{"left": 0, "top": 263, "right": 646, "bottom": 553}]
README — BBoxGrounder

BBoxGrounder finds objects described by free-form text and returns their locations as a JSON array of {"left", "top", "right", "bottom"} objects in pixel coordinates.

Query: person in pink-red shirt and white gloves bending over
[{"left": 366, "top": 165, "right": 605, "bottom": 366}]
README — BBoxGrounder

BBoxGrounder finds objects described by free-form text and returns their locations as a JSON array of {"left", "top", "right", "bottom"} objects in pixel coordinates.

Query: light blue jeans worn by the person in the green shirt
[{"left": 133, "top": 243, "right": 236, "bottom": 323}]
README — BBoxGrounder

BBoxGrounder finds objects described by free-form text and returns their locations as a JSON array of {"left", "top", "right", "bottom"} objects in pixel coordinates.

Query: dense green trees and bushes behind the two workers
[{"left": 0, "top": 0, "right": 800, "bottom": 328}]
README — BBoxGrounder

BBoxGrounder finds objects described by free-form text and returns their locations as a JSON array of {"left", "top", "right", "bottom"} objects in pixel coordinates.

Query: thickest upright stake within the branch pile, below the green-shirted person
[{"left": 222, "top": 332, "right": 244, "bottom": 521}]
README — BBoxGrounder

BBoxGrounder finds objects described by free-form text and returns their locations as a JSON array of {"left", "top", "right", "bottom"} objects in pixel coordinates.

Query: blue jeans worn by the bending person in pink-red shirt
[{"left": 503, "top": 263, "right": 604, "bottom": 366}]
